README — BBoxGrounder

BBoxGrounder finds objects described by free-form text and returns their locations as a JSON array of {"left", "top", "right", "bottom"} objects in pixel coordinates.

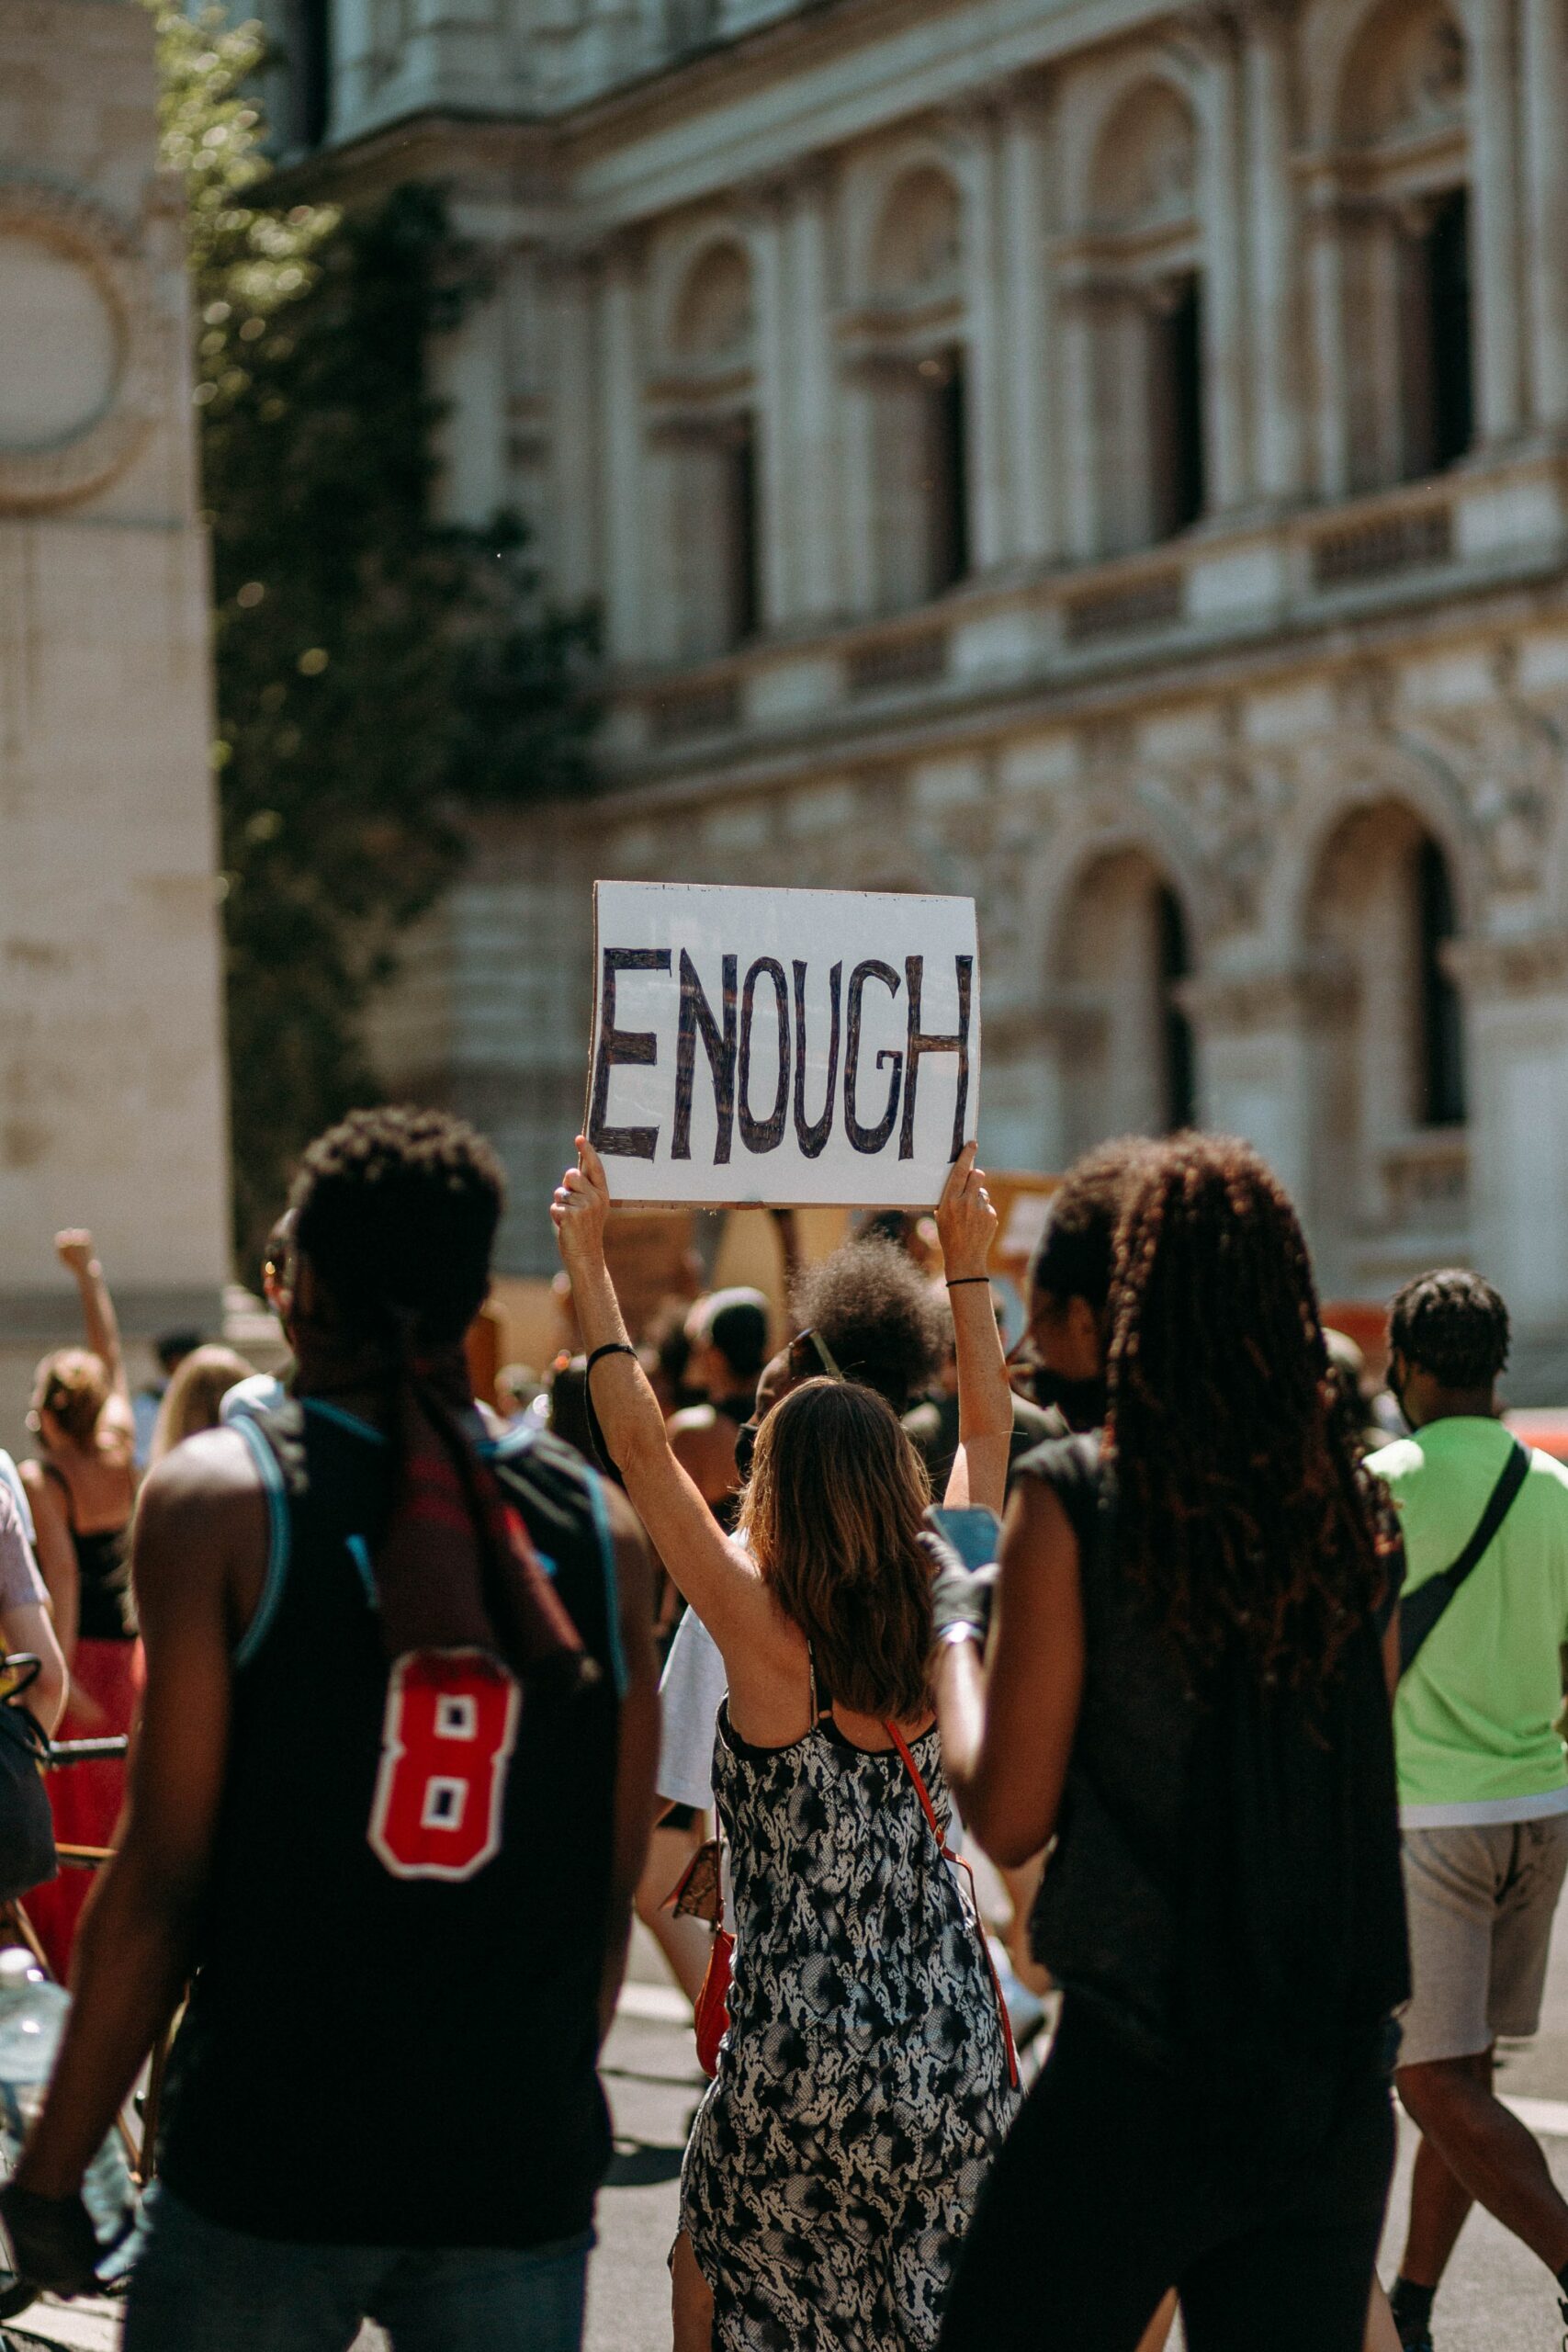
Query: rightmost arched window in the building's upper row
[{"left": 1337, "top": 0, "right": 1474, "bottom": 489}]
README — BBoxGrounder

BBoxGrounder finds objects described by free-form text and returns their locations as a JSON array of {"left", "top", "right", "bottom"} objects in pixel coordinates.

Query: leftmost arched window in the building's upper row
[{"left": 659, "top": 240, "right": 761, "bottom": 661}]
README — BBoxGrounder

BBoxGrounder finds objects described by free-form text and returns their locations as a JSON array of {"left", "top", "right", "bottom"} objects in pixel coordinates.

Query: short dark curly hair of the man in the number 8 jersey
[{"left": 289, "top": 1105, "right": 505, "bottom": 1345}]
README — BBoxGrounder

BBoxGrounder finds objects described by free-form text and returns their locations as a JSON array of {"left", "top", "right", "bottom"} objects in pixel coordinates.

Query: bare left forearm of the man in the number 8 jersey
[{"left": 17, "top": 1856, "right": 195, "bottom": 2197}]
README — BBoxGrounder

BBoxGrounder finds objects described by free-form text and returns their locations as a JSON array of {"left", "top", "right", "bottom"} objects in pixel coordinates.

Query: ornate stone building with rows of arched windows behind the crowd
[{"left": 280, "top": 0, "right": 1568, "bottom": 1395}]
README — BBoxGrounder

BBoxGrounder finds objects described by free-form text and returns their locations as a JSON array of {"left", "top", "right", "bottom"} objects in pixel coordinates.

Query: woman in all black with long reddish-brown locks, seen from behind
[{"left": 933, "top": 1136, "right": 1408, "bottom": 2352}]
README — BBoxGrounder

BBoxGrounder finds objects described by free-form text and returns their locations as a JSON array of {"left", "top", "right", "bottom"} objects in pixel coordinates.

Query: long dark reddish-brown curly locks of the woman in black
[{"left": 1105, "top": 1134, "right": 1384, "bottom": 1691}]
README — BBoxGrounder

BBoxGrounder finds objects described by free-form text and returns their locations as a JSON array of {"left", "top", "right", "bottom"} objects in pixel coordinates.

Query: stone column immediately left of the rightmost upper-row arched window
[{"left": 1241, "top": 0, "right": 1307, "bottom": 501}]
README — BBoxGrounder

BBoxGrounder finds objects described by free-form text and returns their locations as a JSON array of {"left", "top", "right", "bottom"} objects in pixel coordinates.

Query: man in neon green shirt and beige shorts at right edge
[{"left": 1368, "top": 1270, "right": 1568, "bottom": 2352}]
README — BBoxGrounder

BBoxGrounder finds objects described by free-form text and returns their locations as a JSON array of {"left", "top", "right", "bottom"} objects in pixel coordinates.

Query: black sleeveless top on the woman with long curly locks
[{"left": 1021, "top": 1435, "right": 1408, "bottom": 2133}]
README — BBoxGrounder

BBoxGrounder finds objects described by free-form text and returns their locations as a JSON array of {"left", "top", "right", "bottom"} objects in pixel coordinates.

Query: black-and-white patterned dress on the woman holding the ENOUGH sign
[{"left": 682, "top": 1708, "right": 1016, "bottom": 2352}]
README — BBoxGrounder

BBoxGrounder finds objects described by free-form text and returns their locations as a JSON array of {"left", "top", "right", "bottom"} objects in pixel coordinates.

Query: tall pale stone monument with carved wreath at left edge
[{"left": 0, "top": 0, "right": 228, "bottom": 1411}]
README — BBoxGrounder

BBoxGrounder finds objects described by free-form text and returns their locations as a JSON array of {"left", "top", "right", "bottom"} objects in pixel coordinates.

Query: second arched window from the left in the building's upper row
[{"left": 865, "top": 164, "right": 971, "bottom": 612}]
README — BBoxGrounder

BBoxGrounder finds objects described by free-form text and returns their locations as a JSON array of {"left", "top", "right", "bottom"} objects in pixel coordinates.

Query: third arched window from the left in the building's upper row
[{"left": 1081, "top": 83, "right": 1206, "bottom": 555}]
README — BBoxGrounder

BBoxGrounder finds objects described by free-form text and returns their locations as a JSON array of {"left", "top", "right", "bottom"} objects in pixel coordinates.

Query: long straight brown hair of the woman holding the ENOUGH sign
[{"left": 739, "top": 1381, "right": 931, "bottom": 1724}]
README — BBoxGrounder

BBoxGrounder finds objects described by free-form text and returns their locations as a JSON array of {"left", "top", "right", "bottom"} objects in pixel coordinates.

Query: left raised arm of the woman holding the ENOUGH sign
[{"left": 550, "top": 1136, "right": 773, "bottom": 1681}]
